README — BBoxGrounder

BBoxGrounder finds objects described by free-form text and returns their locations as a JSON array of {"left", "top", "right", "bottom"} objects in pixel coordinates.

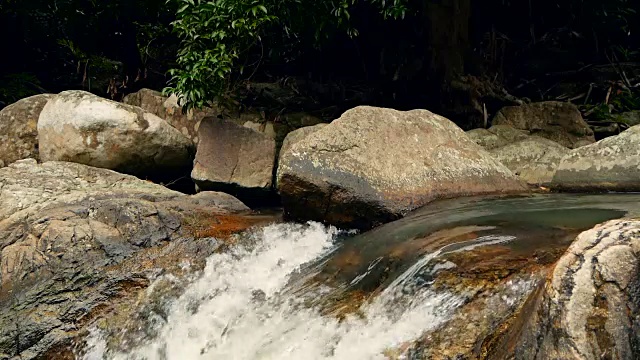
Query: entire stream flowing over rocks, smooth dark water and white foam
[{"left": 81, "top": 194, "right": 640, "bottom": 360}]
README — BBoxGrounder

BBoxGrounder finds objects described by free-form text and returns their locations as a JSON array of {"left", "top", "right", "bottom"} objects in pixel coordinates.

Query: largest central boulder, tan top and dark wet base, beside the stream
[{"left": 278, "top": 106, "right": 524, "bottom": 229}]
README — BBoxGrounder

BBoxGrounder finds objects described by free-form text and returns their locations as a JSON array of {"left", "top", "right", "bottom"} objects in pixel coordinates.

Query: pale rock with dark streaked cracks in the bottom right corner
[{"left": 512, "top": 220, "right": 640, "bottom": 360}]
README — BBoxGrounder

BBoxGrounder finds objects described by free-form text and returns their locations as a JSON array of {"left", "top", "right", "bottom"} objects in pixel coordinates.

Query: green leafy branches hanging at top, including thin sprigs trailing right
[{"left": 164, "top": 0, "right": 408, "bottom": 110}]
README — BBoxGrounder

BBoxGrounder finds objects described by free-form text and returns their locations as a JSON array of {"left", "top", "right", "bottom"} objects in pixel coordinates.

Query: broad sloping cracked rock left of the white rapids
[{"left": 0, "top": 160, "right": 264, "bottom": 359}]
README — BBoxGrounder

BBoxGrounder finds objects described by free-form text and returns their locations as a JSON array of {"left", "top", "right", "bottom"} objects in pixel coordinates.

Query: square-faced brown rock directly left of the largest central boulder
[{"left": 191, "top": 117, "right": 276, "bottom": 203}]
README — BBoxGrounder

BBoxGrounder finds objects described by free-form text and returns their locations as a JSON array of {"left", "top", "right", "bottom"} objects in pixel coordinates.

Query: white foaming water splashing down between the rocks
[{"left": 84, "top": 223, "right": 510, "bottom": 360}]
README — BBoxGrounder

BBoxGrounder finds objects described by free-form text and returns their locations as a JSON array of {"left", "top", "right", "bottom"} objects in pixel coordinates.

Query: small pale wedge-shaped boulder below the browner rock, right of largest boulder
[{"left": 489, "top": 136, "right": 570, "bottom": 185}]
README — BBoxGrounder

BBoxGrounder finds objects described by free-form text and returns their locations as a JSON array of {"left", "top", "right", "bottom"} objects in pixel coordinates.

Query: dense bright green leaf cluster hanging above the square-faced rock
[{"left": 165, "top": 0, "right": 276, "bottom": 107}]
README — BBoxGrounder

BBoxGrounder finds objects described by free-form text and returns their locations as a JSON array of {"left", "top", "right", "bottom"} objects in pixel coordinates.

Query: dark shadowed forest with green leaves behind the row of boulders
[{"left": 0, "top": 0, "right": 640, "bottom": 132}]
